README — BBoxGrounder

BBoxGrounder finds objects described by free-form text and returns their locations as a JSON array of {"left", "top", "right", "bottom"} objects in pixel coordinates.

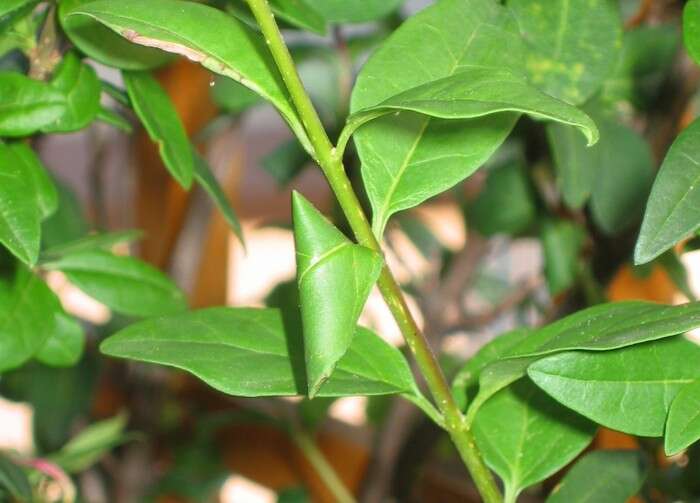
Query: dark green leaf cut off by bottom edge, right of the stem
[{"left": 547, "top": 450, "right": 649, "bottom": 503}]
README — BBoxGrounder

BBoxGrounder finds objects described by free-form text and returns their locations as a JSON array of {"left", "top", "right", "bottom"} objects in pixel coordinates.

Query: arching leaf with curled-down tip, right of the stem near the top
[{"left": 348, "top": 65, "right": 598, "bottom": 146}]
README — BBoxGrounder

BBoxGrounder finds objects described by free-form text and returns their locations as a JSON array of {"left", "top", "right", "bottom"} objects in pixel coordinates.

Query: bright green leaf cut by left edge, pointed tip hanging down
[{"left": 0, "top": 143, "right": 42, "bottom": 265}]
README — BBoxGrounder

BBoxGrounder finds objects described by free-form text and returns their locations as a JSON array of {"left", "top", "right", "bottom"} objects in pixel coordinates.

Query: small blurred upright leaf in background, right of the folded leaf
[{"left": 540, "top": 219, "right": 585, "bottom": 296}]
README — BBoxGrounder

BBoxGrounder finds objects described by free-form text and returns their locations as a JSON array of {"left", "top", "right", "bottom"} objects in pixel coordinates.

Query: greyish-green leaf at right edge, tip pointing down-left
[{"left": 634, "top": 120, "right": 700, "bottom": 264}]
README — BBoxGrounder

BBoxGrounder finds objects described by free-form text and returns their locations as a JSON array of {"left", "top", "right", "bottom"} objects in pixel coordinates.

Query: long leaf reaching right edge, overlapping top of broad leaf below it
[{"left": 508, "top": 301, "right": 700, "bottom": 357}]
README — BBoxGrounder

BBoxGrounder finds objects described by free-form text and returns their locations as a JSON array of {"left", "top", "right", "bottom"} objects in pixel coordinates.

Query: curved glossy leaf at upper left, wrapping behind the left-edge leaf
[{"left": 42, "top": 52, "right": 101, "bottom": 133}]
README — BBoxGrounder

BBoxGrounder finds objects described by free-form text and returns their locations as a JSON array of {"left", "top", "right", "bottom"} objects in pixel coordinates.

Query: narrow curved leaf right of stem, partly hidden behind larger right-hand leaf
[{"left": 452, "top": 328, "right": 530, "bottom": 410}]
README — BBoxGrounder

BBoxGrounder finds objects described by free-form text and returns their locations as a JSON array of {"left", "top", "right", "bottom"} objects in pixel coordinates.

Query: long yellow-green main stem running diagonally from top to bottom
[{"left": 248, "top": 0, "right": 502, "bottom": 503}]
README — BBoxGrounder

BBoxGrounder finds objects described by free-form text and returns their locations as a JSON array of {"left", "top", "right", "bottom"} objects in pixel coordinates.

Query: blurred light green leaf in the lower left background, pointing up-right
[{"left": 49, "top": 414, "right": 127, "bottom": 473}]
